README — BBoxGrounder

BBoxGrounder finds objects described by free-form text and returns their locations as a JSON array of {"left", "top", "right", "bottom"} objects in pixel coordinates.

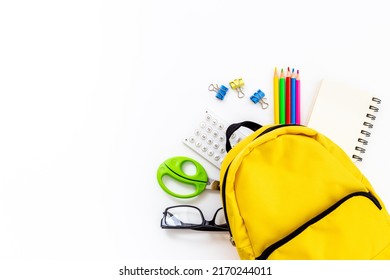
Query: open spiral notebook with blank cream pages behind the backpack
[{"left": 308, "top": 79, "right": 381, "bottom": 164}]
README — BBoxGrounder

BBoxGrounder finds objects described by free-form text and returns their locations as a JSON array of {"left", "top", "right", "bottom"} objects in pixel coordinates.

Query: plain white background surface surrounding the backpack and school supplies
[{"left": 0, "top": 0, "right": 390, "bottom": 260}]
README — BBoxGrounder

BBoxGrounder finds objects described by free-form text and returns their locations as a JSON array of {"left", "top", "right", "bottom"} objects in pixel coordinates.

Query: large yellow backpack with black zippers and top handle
[{"left": 220, "top": 122, "right": 390, "bottom": 260}]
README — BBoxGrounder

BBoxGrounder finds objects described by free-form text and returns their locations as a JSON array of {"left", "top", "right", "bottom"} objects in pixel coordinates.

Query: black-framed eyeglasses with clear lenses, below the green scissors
[{"left": 161, "top": 205, "right": 229, "bottom": 231}]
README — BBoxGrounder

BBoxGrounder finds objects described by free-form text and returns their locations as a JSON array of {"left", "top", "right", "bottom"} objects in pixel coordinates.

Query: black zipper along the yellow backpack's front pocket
[{"left": 256, "top": 192, "right": 382, "bottom": 260}]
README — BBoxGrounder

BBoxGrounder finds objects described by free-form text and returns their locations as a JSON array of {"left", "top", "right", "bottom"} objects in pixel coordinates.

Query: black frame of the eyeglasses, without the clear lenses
[{"left": 160, "top": 205, "right": 229, "bottom": 231}]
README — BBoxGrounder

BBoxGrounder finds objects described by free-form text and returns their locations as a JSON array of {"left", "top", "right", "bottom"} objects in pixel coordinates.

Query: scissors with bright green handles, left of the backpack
[{"left": 157, "top": 156, "right": 219, "bottom": 198}]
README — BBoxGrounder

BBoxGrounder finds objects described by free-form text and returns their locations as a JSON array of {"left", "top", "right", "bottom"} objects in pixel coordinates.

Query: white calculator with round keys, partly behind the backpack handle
[{"left": 183, "top": 110, "right": 245, "bottom": 168}]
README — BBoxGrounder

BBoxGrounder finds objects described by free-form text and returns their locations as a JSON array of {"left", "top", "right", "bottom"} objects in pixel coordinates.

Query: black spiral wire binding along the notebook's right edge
[{"left": 352, "top": 97, "right": 381, "bottom": 161}]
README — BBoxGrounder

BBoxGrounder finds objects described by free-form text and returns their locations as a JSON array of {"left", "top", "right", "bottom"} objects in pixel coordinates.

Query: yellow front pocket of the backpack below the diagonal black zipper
[{"left": 257, "top": 192, "right": 390, "bottom": 260}]
